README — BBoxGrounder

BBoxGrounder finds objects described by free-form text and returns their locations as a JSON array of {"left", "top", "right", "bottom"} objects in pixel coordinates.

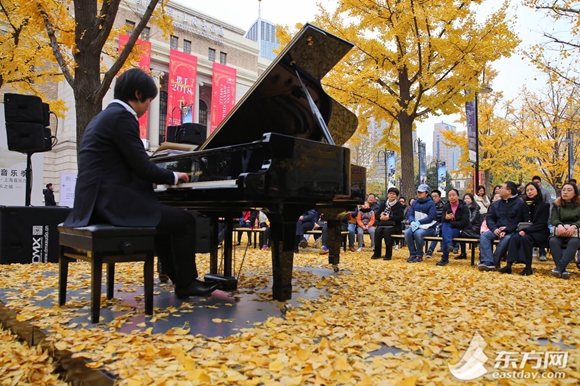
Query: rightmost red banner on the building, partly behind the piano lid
[{"left": 209, "top": 62, "right": 236, "bottom": 134}]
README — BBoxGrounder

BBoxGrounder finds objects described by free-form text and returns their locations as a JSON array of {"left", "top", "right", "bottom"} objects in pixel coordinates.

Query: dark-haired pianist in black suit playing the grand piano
[{"left": 64, "top": 69, "right": 218, "bottom": 299}]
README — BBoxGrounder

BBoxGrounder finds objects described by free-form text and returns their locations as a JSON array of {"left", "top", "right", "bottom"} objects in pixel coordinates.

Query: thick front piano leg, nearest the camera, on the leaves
[{"left": 267, "top": 206, "right": 302, "bottom": 301}]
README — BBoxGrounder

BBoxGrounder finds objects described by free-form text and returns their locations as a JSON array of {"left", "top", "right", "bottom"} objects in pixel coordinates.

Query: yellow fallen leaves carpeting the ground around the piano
[{"left": 0, "top": 237, "right": 580, "bottom": 385}]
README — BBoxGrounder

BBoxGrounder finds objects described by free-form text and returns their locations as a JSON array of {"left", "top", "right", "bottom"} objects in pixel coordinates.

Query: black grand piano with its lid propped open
[{"left": 153, "top": 24, "right": 366, "bottom": 300}]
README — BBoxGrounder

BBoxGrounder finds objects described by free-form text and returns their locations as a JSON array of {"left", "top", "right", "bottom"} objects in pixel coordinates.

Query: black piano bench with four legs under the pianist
[{"left": 58, "top": 224, "right": 157, "bottom": 323}]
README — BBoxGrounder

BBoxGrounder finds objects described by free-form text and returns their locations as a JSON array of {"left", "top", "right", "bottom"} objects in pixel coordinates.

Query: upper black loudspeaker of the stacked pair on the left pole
[{"left": 4, "top": 93, "right": 50, "bottom": 126}]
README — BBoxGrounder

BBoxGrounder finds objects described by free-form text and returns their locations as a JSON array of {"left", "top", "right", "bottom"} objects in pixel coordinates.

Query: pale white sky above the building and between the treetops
[{"left": 174, "top": 0, "right": 552, "bottom": 154}]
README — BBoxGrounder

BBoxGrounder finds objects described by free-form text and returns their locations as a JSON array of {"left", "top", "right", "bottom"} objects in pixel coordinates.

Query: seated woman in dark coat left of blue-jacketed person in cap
[{"left": 371, "top": 187, "right": 405, "bottom": 260}]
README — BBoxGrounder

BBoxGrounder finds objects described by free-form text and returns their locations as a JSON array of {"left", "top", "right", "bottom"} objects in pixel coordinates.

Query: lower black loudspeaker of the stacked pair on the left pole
[{"left": 6, "top": 121, "right": 47, "bottom": 153}]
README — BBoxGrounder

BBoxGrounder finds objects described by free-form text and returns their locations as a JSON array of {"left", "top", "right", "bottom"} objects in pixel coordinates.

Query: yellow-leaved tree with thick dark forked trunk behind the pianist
[{"left": 0, "top": 0, "right": 172, "bottom": 154}]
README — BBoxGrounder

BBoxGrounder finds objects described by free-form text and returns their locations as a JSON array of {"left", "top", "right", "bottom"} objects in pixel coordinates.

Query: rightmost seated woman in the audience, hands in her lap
[{"left": 550, "top": 182, "right": 580, "bottom": 279}]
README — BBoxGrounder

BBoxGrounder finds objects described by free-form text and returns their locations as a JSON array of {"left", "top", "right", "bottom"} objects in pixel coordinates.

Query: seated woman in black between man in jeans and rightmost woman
[{"left": 499, "top": 182, "right": 550, "bottom": 276}]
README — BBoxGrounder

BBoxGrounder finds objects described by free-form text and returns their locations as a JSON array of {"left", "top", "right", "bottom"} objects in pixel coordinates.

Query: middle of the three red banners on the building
[{"left": 167, "top": 49, "right": 197, "bottom": 126}]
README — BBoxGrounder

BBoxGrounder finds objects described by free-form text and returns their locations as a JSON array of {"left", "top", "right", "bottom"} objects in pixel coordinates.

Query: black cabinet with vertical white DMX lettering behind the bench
[{"left": 0, "top": 206, "right": 71, "bottom": 264}]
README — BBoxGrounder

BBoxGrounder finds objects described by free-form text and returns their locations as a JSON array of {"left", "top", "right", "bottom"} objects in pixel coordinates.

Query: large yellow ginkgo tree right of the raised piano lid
[{"left": 281, "top": 0, "right": 519, "bottom": 197}]
